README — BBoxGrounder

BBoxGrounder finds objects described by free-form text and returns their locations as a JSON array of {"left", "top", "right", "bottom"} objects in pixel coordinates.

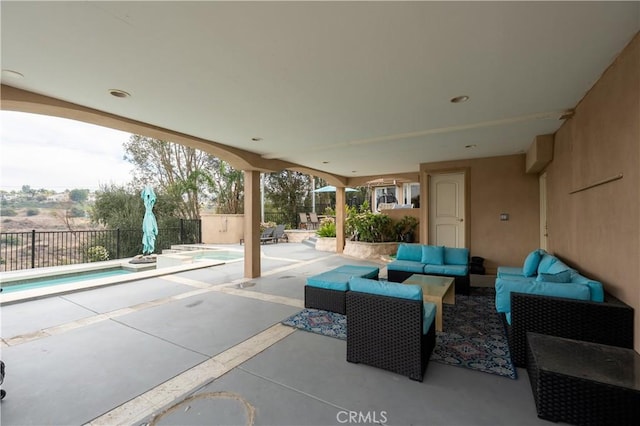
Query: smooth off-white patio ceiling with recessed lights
[{"left": 0, "top": 1, "right": 640, "bottom": 181}]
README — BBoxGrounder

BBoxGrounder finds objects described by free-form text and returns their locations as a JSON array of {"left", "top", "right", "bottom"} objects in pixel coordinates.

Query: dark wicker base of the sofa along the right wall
[{"left": 502, "top": 293, "right": 633, "bottom": 367}]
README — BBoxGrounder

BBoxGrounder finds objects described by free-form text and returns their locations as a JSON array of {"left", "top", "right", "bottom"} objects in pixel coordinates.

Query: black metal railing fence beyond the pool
[{"left": 0, "top": 219, "right": 202, "bottom": 271}]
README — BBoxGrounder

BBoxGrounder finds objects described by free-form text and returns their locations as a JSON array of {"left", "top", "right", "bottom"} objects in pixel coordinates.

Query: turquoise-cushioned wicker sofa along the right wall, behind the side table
[{"left": 496, "top": 250, "right": 634, "bottom": 367}]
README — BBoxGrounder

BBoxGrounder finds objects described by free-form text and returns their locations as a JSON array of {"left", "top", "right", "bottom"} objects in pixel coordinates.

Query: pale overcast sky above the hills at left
[{"left": 0, "top": 111, "right": 133, "bottom": 192}]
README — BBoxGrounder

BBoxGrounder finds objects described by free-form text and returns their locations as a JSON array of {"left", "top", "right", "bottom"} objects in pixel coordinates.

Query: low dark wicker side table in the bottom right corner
[{"left": 527, "top": 333, "right": 640, "bottom": 425}]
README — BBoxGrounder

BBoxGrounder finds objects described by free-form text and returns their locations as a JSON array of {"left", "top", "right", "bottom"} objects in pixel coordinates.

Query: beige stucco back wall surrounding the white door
[{"left": 420, "top": 154, "right": 540, "bottom": 273}]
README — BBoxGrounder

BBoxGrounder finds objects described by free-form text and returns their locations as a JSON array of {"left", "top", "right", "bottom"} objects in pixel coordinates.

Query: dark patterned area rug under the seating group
[{"left": 282, "top": 287, "right": 517, "bottom": 379}]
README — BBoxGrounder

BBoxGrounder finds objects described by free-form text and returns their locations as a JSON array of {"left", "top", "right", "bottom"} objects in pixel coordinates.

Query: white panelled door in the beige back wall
[{"left": 429, "top": 173, "right": 465, "bottom": 247}]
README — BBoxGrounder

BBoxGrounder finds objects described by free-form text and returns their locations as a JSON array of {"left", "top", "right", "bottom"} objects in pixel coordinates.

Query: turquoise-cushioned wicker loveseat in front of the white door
[{"left": 387, "top": 243, "right": 470, "bottom": 294}]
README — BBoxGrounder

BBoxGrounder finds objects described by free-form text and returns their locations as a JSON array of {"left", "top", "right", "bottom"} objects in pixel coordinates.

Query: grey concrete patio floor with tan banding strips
[{"left": 0, "top": 243, "right": 549, "bottom": 426}]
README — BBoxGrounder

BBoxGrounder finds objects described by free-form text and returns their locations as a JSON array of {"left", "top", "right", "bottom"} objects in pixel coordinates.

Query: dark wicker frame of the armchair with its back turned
[{"left": 347, "top": 291, "right": 436, "bottom": 382}]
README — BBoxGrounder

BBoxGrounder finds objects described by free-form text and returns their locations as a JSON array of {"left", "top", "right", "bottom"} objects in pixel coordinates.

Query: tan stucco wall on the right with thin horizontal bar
[{"left": 546, "top": 35, "right": 640, "bottom": 351}]
